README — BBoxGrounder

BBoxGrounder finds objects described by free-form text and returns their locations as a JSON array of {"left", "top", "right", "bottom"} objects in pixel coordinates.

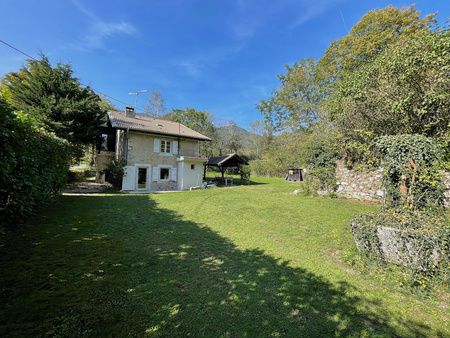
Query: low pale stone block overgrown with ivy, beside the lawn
[{"left": 350, "top": 209, "right": 450, "bottom": 288}]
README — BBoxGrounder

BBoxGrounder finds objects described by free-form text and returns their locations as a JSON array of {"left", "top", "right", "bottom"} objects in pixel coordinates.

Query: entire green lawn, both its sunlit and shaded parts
[{"left": 0, "top": 178, "right": 450, "bottom": 337}]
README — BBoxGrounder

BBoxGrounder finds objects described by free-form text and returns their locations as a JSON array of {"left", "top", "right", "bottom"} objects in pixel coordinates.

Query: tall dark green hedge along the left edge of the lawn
[{"left": 0, "top": 97, "right": 70, "bottom": 230}]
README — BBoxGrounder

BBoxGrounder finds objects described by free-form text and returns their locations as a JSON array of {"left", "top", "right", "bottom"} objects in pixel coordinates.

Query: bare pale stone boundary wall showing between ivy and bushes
[{"left": 330, "top": 161, "right": 450, "bottom": 207}]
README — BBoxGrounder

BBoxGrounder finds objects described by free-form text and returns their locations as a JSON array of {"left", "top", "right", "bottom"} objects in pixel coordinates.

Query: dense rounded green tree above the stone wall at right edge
[{"left": 328, "top": 29, "right": 450, "bottom": 161}]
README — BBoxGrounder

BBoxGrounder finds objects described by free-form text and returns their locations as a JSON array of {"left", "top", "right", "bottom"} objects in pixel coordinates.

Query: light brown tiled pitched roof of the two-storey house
[{"left": 108, "top": 111, "right": 211, "bottom": 141}]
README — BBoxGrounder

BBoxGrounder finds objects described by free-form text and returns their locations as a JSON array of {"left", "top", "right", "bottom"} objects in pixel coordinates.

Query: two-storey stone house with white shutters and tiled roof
[{"left": 97, "top": 106, "right": 211, "bottom": 192}]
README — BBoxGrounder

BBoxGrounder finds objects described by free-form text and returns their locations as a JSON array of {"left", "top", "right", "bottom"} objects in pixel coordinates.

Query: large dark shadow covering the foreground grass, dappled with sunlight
[{"left": 0, "top": 195, "right": 442, "bottom": 337}]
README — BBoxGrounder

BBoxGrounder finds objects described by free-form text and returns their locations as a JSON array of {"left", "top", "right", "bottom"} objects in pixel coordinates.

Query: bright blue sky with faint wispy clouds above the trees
[{"left": 0, "top": 0, "right": 450, "bottom": 129}]
